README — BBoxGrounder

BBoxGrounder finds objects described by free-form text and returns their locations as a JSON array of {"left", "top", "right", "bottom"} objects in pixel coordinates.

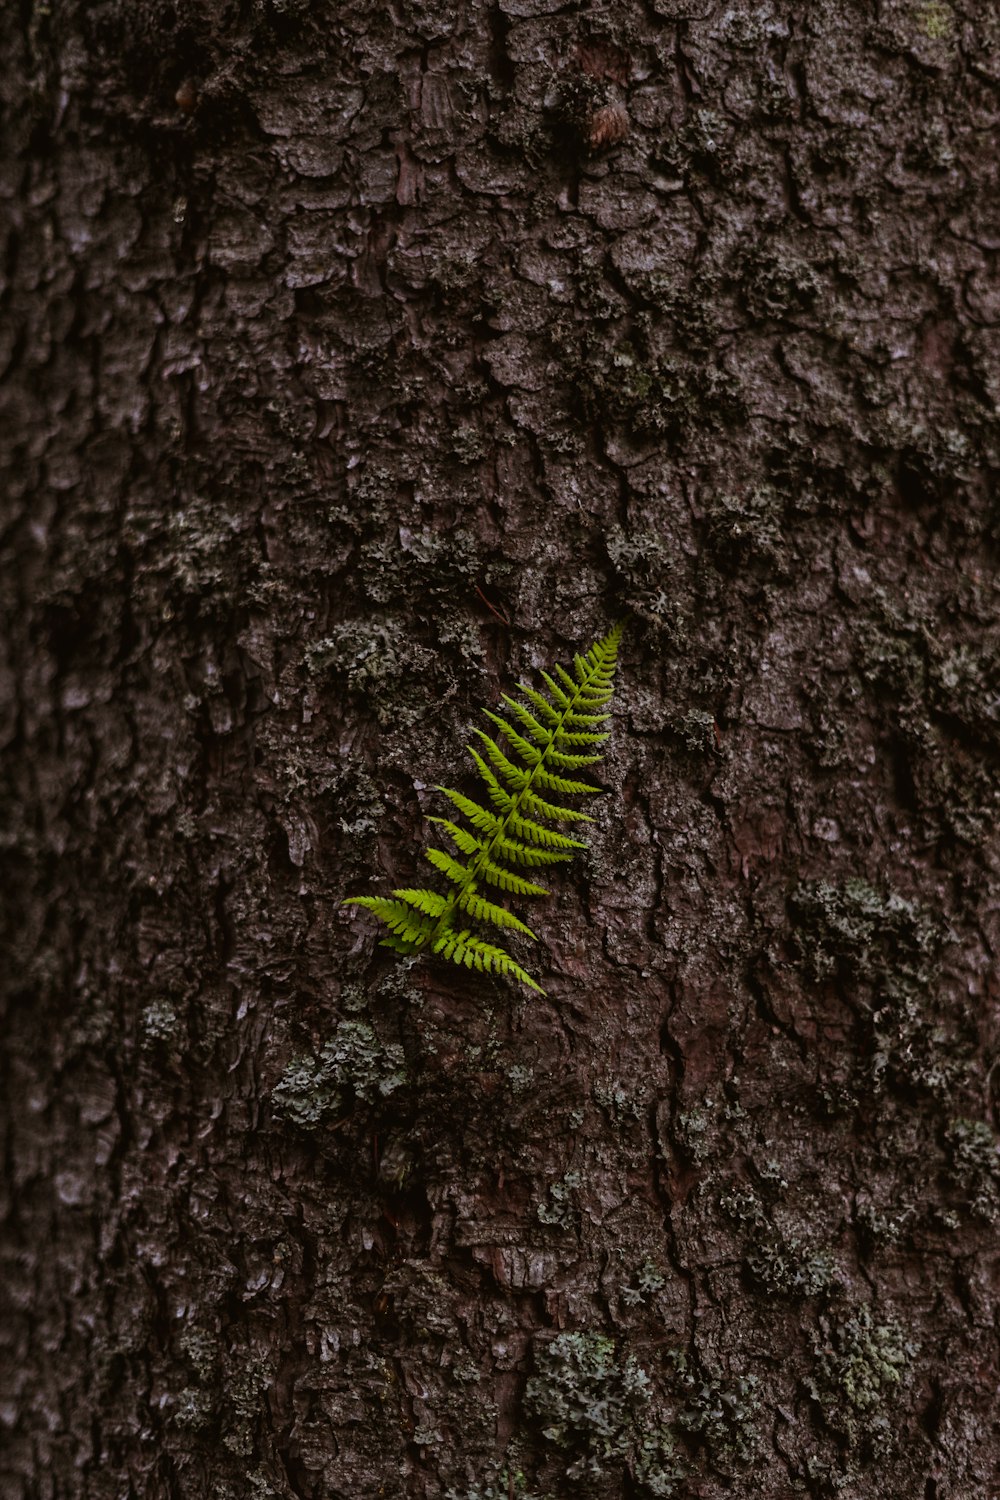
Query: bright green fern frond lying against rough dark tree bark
[{"left": 343, "top": 623, "right": 622, "bottom": 993}]
